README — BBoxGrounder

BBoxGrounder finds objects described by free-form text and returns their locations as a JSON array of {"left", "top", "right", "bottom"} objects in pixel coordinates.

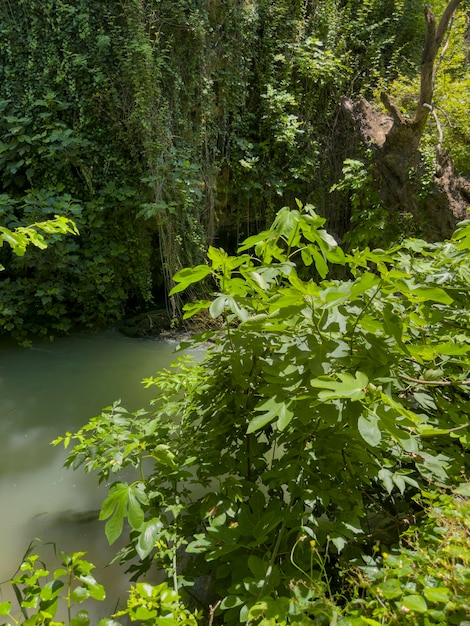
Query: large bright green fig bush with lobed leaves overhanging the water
[{"left": 46, "top": 204, "right": 470, "bottom": 624}]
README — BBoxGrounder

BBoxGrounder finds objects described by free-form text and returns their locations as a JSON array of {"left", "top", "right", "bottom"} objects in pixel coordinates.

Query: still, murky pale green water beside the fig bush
[{"left": 0, "top": 331, "right": 184, "bottom": 615}]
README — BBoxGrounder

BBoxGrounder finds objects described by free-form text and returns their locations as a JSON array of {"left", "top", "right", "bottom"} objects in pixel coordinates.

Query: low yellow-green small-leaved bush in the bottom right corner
[{"left": 339, "top": 483, "right": 470, "bottom": 626}]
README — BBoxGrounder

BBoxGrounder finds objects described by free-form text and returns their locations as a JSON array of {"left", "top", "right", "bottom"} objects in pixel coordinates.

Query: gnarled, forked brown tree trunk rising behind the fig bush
[{"left": 342, "top": 0, "right": 470, "bottom": 241}]
